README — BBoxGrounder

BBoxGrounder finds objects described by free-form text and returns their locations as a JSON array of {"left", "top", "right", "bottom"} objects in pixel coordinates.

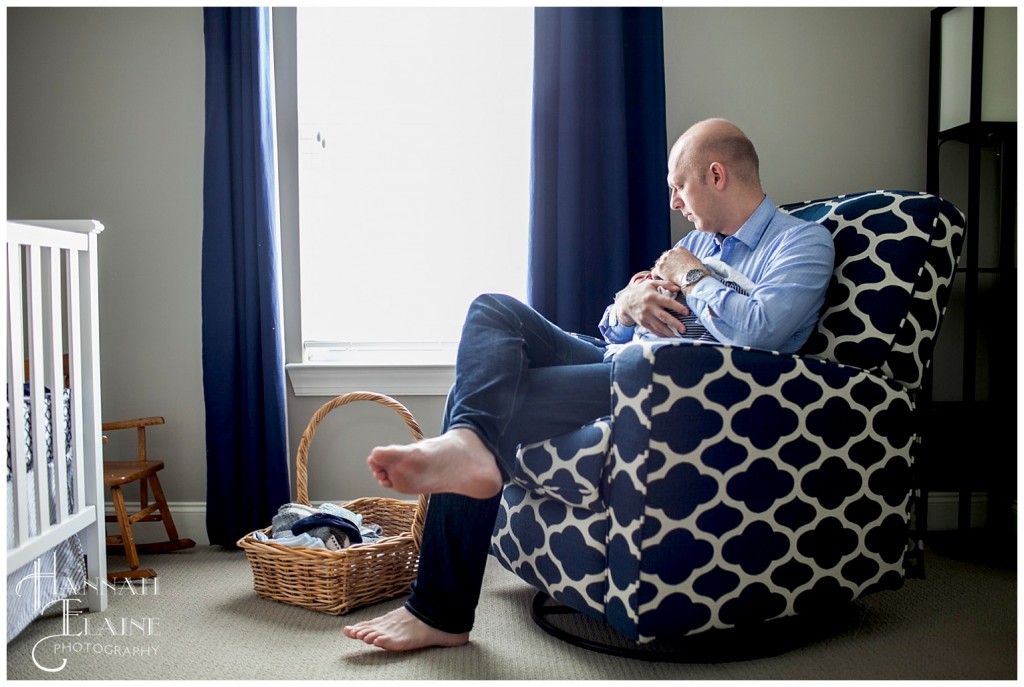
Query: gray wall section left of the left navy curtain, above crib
[{"left": 6, "top": 7, "right": 206, "bottom": 502}]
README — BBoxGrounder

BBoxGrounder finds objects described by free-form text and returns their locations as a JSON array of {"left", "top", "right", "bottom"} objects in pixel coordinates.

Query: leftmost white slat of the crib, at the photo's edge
[{"left": 7, "top": 244, "right": 31, "bottom": 547}]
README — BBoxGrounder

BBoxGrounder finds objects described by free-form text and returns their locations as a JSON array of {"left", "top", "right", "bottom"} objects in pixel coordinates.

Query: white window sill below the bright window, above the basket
[{"left": 285, "top": 362, "right": 455, "bottom": 396}]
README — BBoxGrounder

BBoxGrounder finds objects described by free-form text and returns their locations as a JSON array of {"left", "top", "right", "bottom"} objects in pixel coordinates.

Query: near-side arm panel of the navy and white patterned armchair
[{"left": 606, "top": 341, "right": 914, "bottom": 637}]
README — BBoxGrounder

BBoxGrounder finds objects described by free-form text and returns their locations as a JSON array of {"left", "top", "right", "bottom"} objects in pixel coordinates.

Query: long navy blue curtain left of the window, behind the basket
[{"left": 203, "top": 7, "right": 290, "bottom": 546}]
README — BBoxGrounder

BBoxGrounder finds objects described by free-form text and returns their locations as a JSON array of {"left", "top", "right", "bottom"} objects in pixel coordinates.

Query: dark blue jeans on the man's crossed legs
[{"left": 406, "top": 295, "right": 611, "bottom": 633}]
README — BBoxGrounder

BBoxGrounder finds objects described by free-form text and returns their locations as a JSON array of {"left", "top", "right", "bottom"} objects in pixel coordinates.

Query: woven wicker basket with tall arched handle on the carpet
[{"left": 238, "top": 391, "right": 427, "bottom": 615}]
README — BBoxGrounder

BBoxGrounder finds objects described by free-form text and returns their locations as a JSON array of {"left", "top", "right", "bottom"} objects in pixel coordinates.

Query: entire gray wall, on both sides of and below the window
[{"left": 7, "top": 7, "right": 929, "bottom": 539}]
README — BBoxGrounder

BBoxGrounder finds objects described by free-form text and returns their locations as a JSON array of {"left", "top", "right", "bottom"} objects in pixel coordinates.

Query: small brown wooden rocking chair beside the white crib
[{"left": 103, "top": 418, "right": 196, "bottom": 582}]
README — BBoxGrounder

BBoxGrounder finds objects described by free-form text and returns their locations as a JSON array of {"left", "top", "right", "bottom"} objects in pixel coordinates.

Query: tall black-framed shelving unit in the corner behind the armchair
[{"left": 921, "top": 7, "right": 1017, "bottom": 565}]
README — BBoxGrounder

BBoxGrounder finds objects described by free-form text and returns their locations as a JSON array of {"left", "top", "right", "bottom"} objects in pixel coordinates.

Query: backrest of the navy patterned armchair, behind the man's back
[{"left": 781, "top": 190, "right": 965, "bottom": 389}]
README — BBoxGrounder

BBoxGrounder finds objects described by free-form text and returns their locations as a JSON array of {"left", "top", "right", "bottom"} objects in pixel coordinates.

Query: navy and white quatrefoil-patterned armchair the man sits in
[{"left": 492, "top": 191, "right": 964, "bottom": 643}]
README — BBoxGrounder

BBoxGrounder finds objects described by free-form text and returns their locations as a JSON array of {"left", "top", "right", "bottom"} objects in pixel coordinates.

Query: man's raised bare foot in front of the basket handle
[{"left": 367, "top": 427, "right": 502, "bottom": 499}]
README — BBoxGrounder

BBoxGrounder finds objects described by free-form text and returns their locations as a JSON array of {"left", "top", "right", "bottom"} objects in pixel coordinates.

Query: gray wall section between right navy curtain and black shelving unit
[{"left": 664, "top": 7, "right": 931, "bottom": 241}]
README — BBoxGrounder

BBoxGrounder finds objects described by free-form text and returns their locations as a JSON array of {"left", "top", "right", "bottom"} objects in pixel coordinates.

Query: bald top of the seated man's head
[{"left": 669, "top": 119, "right": 761, "bottom": 192}]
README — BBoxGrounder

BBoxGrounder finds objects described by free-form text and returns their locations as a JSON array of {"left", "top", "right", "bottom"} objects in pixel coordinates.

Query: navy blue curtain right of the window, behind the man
[{"left": 528, "top": 7, "right": 671, "bottom": 334}]
